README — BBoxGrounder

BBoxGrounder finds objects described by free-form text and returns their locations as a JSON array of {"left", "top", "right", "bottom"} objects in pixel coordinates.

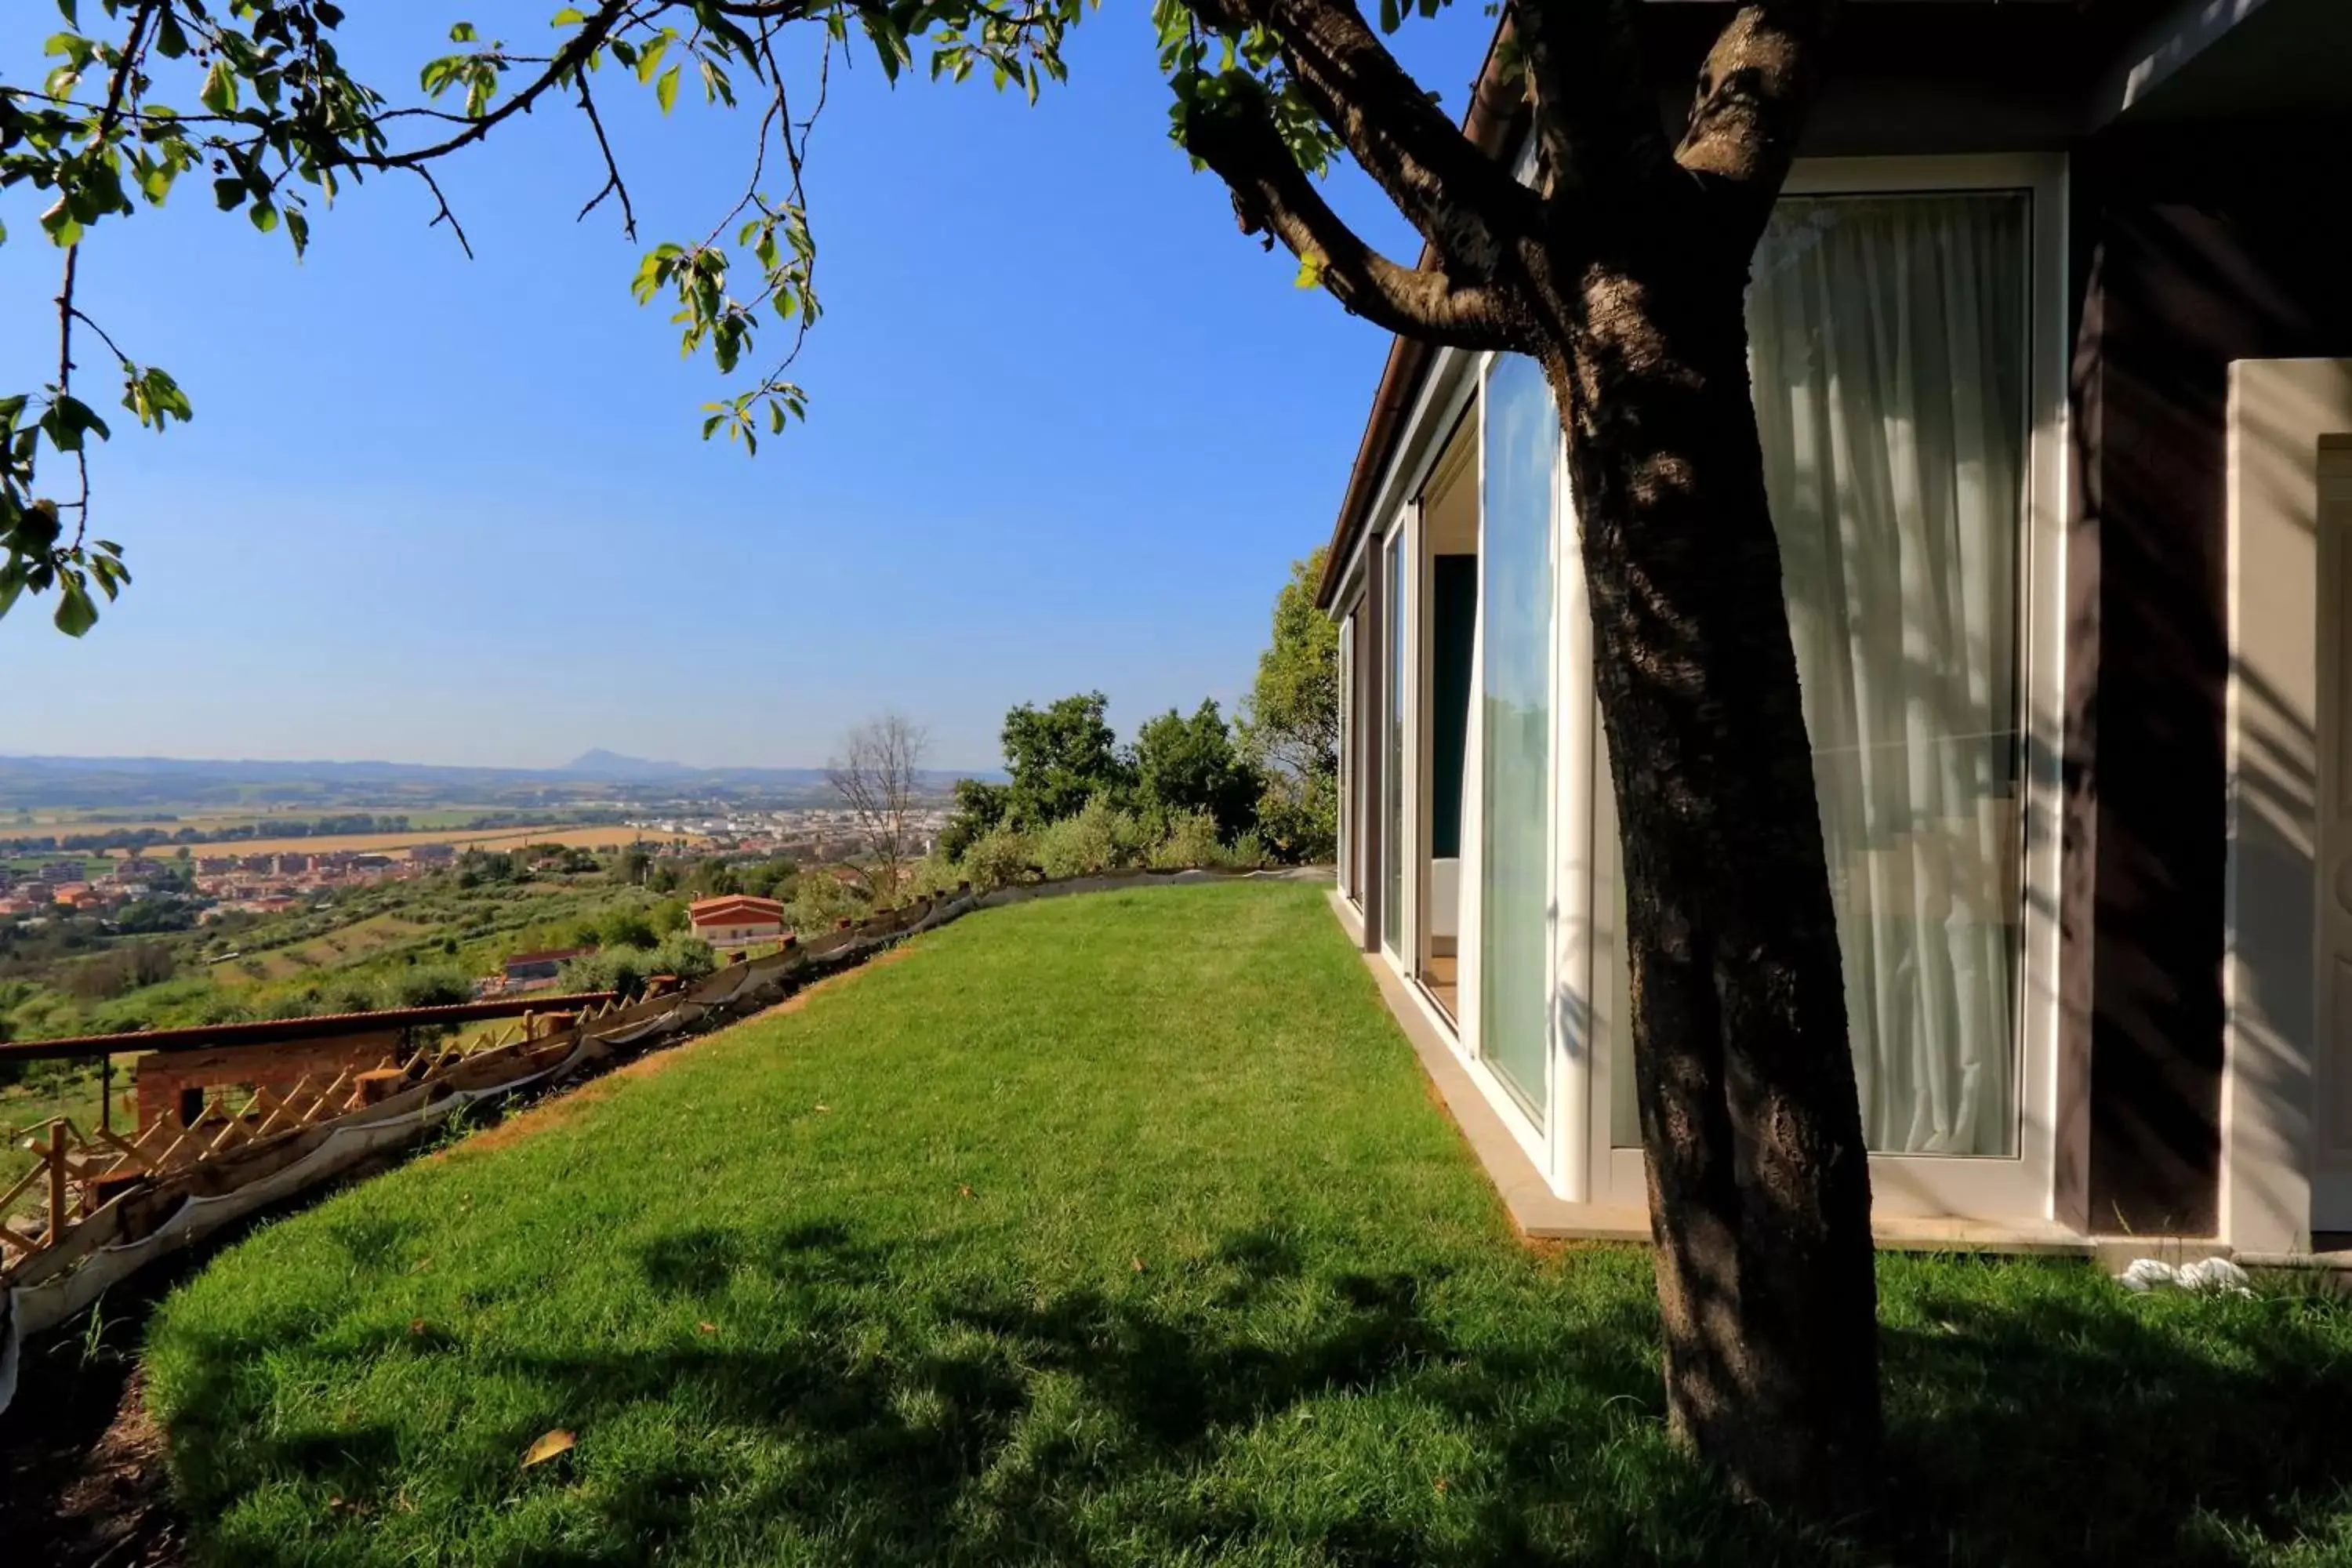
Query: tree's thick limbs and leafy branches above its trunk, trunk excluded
[{"left": 0, "top": 0, "right": 1832, "bottom": 635}]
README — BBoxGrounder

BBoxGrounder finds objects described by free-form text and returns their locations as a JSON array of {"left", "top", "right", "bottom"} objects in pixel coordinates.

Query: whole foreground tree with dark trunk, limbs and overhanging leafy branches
[{"left": 0, "top": 0, "right": 1879, "bottom": 1507}]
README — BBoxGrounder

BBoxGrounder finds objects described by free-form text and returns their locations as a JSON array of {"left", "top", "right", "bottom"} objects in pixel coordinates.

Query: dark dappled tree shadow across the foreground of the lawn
[{"left": 156, "top": 1222, "right": 2352, "bottom": 1568}]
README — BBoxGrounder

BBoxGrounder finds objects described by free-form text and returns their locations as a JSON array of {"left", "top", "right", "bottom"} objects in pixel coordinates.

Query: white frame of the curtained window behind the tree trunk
[{"left": 1557, "top": 153, "right": 2089, "bottom": 1229}]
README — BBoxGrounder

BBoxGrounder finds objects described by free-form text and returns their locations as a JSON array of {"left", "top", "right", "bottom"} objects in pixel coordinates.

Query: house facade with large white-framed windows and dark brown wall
[{"left": 1322, "top": 0, "right": 2352, "bottom": 1253}]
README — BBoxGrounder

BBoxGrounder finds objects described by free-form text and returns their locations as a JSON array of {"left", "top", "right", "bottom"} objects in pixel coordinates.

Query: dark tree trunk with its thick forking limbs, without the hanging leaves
[{"left": 1181, "top": 0, "right": 1879, "bottom": 1516}]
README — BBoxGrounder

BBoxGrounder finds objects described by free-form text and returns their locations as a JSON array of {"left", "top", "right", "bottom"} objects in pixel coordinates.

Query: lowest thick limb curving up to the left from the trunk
[{"left": 1188, "top": 71, "right": 1522, "bottom": 350}]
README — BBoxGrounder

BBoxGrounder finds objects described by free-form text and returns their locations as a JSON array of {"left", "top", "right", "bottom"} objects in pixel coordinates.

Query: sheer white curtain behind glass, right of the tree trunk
[{"left": 1748, "top": 193, "right": 2030, "bottom": 1154}]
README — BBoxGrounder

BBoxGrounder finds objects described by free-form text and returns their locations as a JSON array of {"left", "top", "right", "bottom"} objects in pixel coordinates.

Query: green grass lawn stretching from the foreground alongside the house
[{"left": 148, "top": 884, "right": 2352, "bottom": 1566}]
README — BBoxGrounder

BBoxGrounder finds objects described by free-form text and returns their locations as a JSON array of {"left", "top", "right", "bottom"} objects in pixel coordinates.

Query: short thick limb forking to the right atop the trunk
[{"left": 1675, "top": 0, "right": 1839, "bottom": 233}]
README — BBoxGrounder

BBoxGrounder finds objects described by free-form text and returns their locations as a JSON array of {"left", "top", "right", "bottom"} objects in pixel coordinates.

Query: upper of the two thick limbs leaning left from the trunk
[{"left": 1185, "top": 0, "right": 1534, "bottom": 280}]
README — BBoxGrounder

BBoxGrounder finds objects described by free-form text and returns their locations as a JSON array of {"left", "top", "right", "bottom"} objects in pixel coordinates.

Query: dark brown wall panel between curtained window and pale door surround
[{"left": 2070, "top": 127, "right": 2352, "bottom": 1234}]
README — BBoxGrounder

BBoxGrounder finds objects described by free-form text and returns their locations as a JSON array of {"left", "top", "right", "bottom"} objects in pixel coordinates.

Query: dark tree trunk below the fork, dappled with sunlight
[{"left": 1541, "top": 245, "right": 1879, "bottom": 1516}]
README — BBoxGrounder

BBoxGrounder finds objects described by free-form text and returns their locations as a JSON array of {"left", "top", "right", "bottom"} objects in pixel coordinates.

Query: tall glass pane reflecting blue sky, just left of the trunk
[{"left": 1479, "top": 355, "right": 1559, "bottom": 1123}]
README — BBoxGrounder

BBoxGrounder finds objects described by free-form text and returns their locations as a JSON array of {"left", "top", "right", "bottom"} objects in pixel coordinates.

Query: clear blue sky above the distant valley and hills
[{"left": 0, "top": 0, "right": 1491, "bottom": 767}]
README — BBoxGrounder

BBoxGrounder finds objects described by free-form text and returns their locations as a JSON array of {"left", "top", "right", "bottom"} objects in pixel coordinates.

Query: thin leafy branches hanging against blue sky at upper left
[{"left": 0, "top": 0, "right": 1089, "bottom": 637}]
